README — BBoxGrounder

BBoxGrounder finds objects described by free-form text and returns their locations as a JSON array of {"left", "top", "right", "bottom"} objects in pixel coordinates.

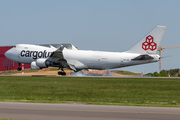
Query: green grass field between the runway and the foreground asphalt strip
[{"left": 0, "top": 76, "right": 180, "bottom": 107}]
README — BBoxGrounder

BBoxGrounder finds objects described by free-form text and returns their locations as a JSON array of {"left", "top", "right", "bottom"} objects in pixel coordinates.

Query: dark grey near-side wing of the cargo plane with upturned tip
[{"left": 48, "top": 45, "right": 77, "bottom": 71}]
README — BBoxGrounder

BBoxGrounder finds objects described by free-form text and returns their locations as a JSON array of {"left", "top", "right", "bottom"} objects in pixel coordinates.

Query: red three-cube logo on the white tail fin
[{"left": 142, "top": 35, "right": 157, "bottom": 51}]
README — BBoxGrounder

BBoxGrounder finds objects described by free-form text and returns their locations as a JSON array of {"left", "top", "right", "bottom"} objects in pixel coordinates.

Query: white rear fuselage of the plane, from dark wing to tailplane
[{"left": 63, "top": 50, "right": 154, "bottom": 69}]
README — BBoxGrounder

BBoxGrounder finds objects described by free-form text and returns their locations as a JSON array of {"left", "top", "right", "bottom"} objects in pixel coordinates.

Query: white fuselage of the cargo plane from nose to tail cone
[{"left": 5, "top": 44, "right": 159, "bottom": 70}]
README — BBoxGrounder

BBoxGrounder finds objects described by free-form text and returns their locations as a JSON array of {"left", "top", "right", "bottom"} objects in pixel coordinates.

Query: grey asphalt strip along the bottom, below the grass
[{"left": 0, "top": 102, "right": 180, "bottom": 120}]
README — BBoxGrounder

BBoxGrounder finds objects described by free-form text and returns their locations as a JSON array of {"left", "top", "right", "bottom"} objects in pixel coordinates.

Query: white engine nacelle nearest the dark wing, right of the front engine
[{"left": 36, "top": 58, "right": 53, "bottom": 68}]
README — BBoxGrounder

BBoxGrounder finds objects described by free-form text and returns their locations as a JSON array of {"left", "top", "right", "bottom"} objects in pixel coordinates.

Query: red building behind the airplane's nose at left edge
[{"left": 0, "top": 46, "right": 31, "bottom": 71}]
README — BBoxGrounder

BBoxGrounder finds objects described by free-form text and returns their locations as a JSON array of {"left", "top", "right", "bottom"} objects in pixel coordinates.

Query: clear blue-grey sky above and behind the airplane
[{"left": 0, "top": 0, "right": 180, "bottom": 73}]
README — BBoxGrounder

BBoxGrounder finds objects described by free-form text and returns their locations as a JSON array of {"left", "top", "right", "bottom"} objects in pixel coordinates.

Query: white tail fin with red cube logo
[{"left": 127, "top": 26, "right": 166, "bottom": 54}]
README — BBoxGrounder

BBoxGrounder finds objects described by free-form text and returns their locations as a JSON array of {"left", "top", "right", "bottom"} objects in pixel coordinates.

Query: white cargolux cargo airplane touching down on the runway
[{"left": 5, "top": 26, "right": 166, "bottom": 75}]
